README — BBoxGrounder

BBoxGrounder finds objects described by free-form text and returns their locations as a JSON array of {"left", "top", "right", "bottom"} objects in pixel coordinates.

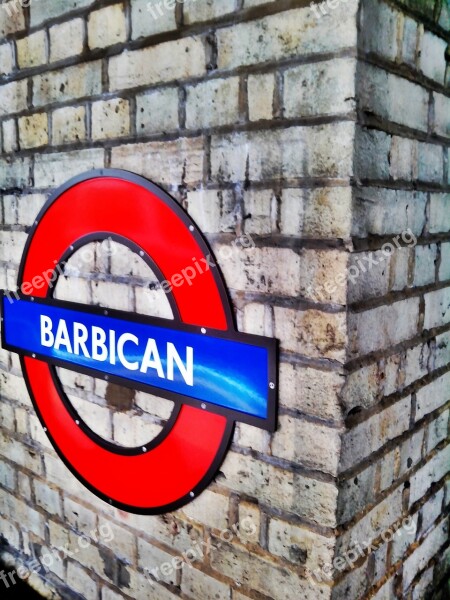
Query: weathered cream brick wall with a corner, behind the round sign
[{"left": 0, "top": 0, "right": 450, "bottom": 600}]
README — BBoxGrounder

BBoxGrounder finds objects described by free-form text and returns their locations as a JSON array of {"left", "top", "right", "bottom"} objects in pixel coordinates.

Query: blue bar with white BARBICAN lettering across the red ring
[{"left": 3, "top": 297, "right": 272, "bottom": 419}]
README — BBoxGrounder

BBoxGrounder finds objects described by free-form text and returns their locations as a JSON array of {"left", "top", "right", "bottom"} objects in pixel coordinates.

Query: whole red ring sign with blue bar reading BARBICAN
[{"left": 1, "top": 170, "right": 276, "bottom": 514}]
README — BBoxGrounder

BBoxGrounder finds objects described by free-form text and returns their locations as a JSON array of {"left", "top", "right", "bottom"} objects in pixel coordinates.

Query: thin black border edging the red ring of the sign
[{"left": 0, "top": 169, "right": 278, "bottom": 515}]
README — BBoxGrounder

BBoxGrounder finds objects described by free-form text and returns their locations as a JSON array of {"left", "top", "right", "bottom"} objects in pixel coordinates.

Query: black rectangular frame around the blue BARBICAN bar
[{"left": 0, "top": 290, "right": 277, "bottom": 434}]
